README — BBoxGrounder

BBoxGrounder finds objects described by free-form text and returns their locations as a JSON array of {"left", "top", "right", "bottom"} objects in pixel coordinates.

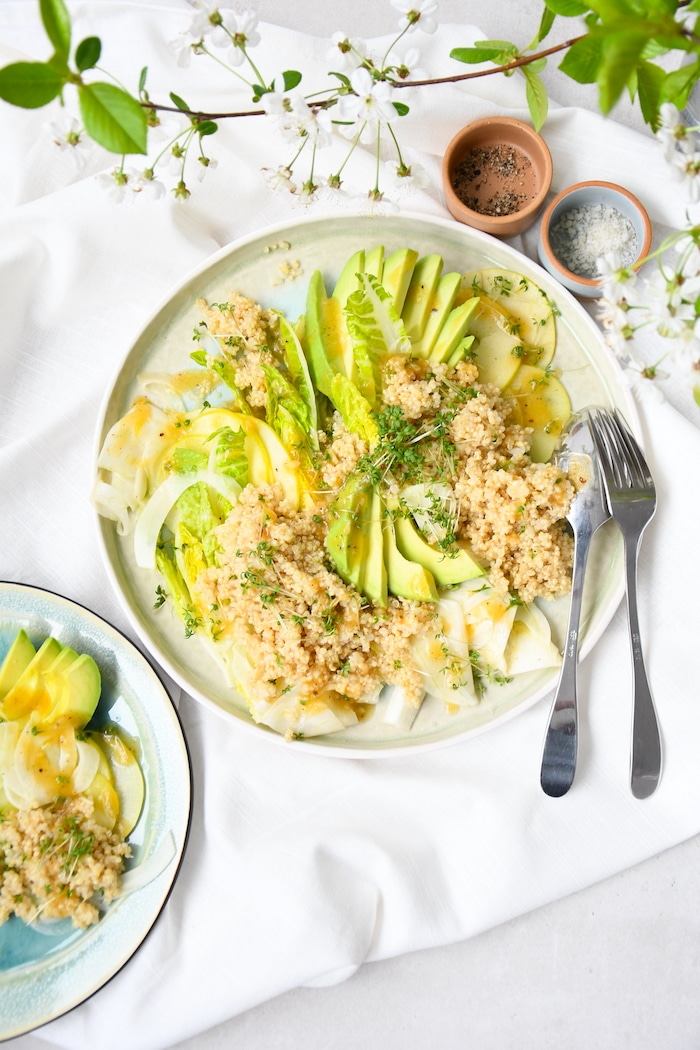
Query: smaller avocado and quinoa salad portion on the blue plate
[{"left": 0, "top": 628, "right": 145, "bottom": 928}]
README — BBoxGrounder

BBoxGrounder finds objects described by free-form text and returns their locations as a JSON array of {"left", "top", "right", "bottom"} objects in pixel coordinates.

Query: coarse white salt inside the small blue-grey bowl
[{"left": 549, "top": 204, "right": 638, "bottom": 278}]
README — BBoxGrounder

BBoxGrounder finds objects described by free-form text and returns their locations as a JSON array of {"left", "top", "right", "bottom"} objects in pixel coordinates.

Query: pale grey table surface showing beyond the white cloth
[{"left": 12, "top": 0, "right": 700, "bottom": 1050}]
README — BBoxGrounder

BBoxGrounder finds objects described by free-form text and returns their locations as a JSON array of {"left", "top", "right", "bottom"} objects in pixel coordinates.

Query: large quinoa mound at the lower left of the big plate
[{"left": 198, "top": 485, "right": 432, "bottom": 705}]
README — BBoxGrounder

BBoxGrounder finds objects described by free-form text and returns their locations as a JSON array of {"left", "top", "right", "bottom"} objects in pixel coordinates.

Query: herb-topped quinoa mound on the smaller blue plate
[{"left": 0, "top": 795, "right": 131, "bottom": 928}]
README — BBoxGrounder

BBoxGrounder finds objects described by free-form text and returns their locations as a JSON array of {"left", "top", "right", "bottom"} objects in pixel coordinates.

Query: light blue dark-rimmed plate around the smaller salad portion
[{"left": 0, "top": 583, "right": 191, "bottom": 1040}]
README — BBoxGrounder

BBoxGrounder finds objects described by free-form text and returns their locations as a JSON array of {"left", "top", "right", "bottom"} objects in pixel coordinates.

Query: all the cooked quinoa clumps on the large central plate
[{"left": 187, "top": 287, "right": 574, "bottom": 706}]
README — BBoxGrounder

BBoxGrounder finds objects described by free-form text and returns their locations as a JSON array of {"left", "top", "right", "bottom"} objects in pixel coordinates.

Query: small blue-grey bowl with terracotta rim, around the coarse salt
[{"left": 537, "top": 182, "right": 652, "bottom": 299}]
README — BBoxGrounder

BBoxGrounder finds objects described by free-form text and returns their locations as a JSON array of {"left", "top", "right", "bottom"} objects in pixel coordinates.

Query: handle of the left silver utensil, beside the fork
[{"left": 539, "top": 529, "right": 593, "bottom": 798}]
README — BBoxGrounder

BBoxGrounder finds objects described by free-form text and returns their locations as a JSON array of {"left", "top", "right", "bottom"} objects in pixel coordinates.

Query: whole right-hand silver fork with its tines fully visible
[{"left": 589, "top": 408, "right": 661, "bottom": 798}]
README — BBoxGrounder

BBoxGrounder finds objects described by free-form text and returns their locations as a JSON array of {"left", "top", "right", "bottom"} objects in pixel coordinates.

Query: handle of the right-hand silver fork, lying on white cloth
[{"left": 624, "top": 532, "right": 661, "bottom": 798}]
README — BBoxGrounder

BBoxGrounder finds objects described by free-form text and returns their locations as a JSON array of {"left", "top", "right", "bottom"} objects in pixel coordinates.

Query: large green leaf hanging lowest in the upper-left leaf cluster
[{"left": 78, "top": 83, "right": 148, "bottom": 153}]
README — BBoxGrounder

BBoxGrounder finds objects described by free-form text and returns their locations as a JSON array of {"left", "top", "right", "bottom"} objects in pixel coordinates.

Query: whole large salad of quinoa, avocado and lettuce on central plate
[{"left": 93, "top": 248, "right": 575, "bottom": 739}]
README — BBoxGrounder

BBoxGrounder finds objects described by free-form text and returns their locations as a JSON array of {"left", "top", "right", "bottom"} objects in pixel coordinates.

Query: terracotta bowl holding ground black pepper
[{"left": 442, "top": 117, "right": 552, "bottom": 237}]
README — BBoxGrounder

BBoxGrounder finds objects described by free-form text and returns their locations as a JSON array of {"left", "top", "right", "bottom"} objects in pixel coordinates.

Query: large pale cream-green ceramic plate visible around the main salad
[{"left": 91, "top": 216, "right": 634, "bottom": 757}]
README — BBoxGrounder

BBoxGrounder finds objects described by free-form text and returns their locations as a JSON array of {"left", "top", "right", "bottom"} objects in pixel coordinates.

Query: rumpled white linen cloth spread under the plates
[{"left": 0, "top": 0, "right": 700, "bottom": 1050}]
